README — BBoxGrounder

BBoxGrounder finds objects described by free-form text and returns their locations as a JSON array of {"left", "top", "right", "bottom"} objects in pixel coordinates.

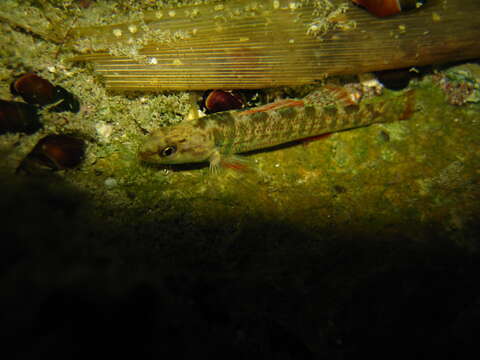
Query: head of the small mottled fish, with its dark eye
[{"left": 139, "top": 124, "right": 215, "bottom": 165}]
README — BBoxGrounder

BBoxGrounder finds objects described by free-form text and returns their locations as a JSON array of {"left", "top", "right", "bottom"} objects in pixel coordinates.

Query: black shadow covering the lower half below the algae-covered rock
[{"left": 0, "top": 176, "right": 480, "bottom": 359}]
